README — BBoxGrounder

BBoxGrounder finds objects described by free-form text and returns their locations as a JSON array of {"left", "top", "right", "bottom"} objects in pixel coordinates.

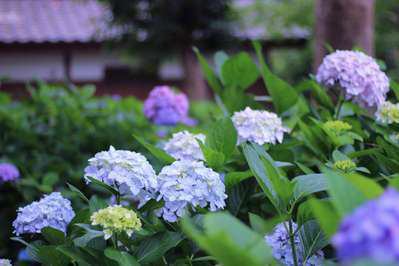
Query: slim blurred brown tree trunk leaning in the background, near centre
[{"left": 182, "top": 46, "right": 209, "bottom": 100}]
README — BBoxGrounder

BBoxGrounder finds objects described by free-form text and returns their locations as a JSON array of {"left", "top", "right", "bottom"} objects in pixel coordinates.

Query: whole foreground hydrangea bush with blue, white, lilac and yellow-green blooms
[{"left": 4, "top": 43, "right": 399, "bottom": 266}]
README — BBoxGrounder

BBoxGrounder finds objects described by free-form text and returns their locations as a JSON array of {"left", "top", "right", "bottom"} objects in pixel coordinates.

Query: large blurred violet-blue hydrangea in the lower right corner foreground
[{"left": 332, "top": 188, "right": 399, "bottom": 264}]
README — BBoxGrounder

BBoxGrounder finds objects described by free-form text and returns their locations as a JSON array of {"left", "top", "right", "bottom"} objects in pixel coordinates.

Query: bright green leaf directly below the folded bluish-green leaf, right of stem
[{"left": 308, "top": 198, "right": 340, "bottom": 238}]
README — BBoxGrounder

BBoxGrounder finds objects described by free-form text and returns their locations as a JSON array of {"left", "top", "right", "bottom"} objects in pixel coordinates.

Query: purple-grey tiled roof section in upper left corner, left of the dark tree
[{"left": 0, "top": 0, "right": 108, "bottom": 43}]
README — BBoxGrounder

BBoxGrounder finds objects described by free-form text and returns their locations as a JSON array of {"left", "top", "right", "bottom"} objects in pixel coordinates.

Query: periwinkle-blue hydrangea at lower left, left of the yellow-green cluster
[{"left": 13, "top": 192, "right": 75, "bottom": 236}]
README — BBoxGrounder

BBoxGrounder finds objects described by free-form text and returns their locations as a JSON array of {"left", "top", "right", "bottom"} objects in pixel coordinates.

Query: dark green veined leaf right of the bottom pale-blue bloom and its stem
[{"left": 299, "top": 220, "right": 328, "bottom": 264}]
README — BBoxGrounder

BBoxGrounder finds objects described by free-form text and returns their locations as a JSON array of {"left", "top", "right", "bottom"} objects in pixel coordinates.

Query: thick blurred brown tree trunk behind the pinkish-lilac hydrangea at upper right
[{"left": 314, "top": 0, "right": 374, "bottom": 69}]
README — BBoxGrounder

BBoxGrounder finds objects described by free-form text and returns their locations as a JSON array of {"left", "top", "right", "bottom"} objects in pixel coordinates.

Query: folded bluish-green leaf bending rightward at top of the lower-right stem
[{"left": 291, "top": 174, "right": 327, "bottom": 199}]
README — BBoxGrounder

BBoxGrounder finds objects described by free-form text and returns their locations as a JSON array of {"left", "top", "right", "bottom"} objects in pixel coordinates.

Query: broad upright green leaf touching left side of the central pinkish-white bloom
[{"left": 206, "top": 117, "right": 237, "bottom": 159}]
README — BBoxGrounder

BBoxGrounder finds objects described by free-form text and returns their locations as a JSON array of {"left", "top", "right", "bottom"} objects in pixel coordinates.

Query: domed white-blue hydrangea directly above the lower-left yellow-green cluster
[{"left": 84, "top": 146, "right": 157, "bottom": 204}]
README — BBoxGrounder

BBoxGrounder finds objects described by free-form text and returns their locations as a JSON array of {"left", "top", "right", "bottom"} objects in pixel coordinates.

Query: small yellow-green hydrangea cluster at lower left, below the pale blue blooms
[{"left": 90, "top": 205, "right": 141, "bottom": 239}]
